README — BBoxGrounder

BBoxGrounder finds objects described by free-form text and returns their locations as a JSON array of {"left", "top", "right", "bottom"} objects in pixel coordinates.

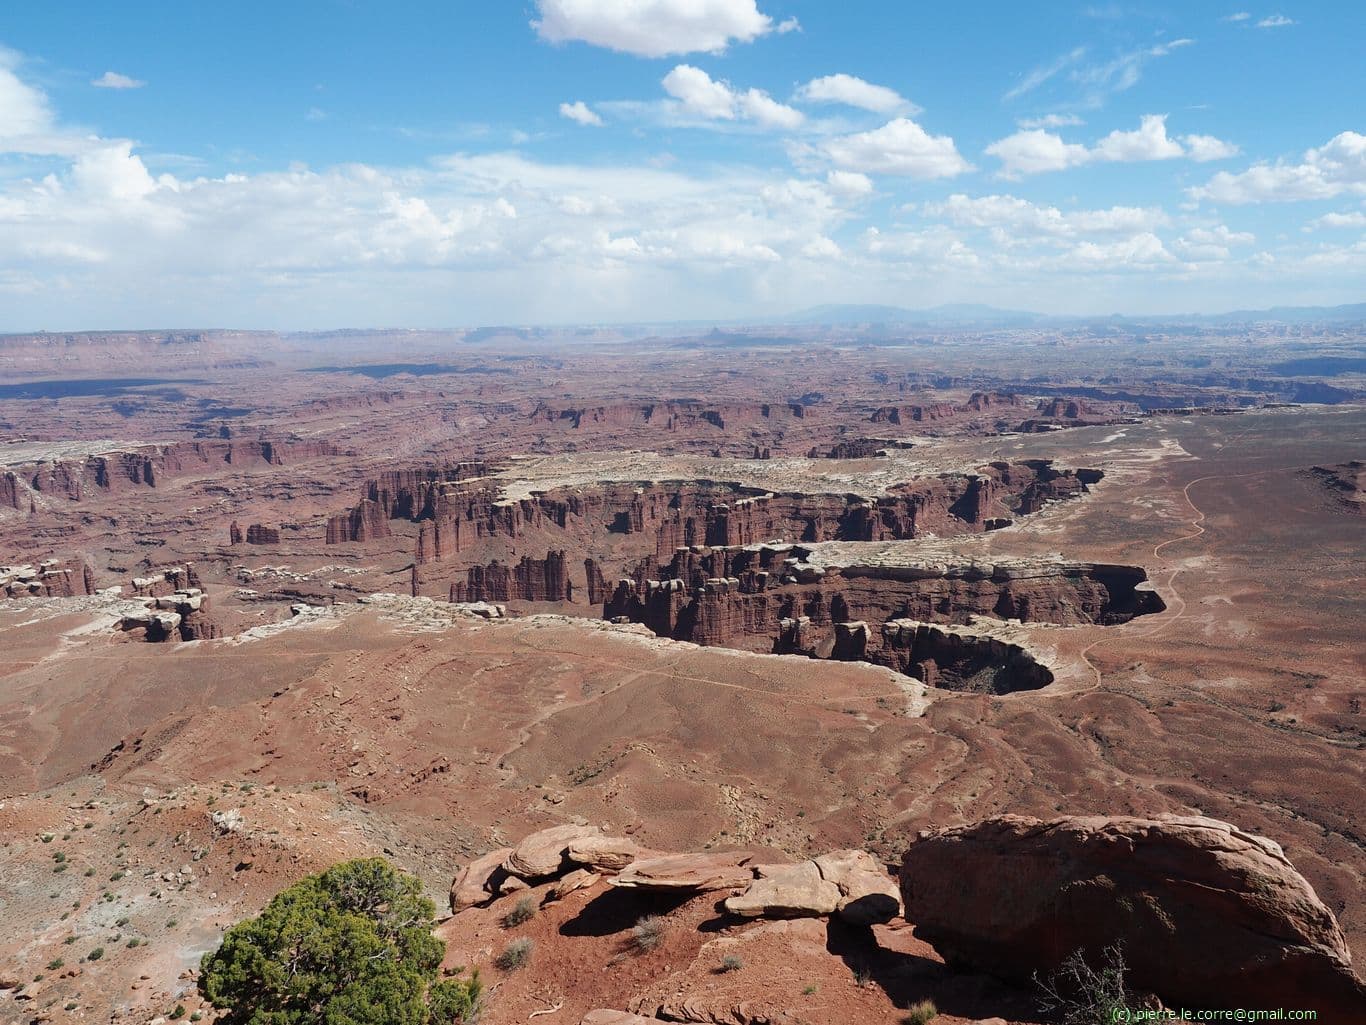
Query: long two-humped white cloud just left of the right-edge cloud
[{"left": 986, "top": 113, "right": 1238, "bottom": 179}]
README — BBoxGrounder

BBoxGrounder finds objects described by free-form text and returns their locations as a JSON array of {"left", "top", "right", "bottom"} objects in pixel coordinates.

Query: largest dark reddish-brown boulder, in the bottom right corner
[{"left": 902, "top": 816, "right": 1366, "bottom": 1021}]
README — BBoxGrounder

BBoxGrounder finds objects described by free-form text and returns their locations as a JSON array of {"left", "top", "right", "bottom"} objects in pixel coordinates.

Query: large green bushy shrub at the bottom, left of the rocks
[{"left": 199, "top": 858, "right": 481, "bottom": 1025}]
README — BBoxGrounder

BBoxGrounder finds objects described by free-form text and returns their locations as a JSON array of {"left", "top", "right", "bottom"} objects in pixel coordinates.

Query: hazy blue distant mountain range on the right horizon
[{"left": 759, "top": 302, "right": 1366, "bottom": 328}]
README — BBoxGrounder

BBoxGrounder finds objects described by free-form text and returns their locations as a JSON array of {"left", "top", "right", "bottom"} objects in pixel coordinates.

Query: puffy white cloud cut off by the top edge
[{"left": 531, "top": 0, "right": 775, "bottom": 57}]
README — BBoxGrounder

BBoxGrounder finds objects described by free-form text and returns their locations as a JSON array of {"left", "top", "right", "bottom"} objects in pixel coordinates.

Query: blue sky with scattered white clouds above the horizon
[{"left": 0, "top": 0, "right": 1366, "bottom": 331}]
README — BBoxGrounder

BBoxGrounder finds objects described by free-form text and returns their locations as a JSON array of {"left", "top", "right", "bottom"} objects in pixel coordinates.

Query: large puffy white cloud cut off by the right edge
[{"left": 1187, "top": 131, "right": 1366, "bottom": 205}]
